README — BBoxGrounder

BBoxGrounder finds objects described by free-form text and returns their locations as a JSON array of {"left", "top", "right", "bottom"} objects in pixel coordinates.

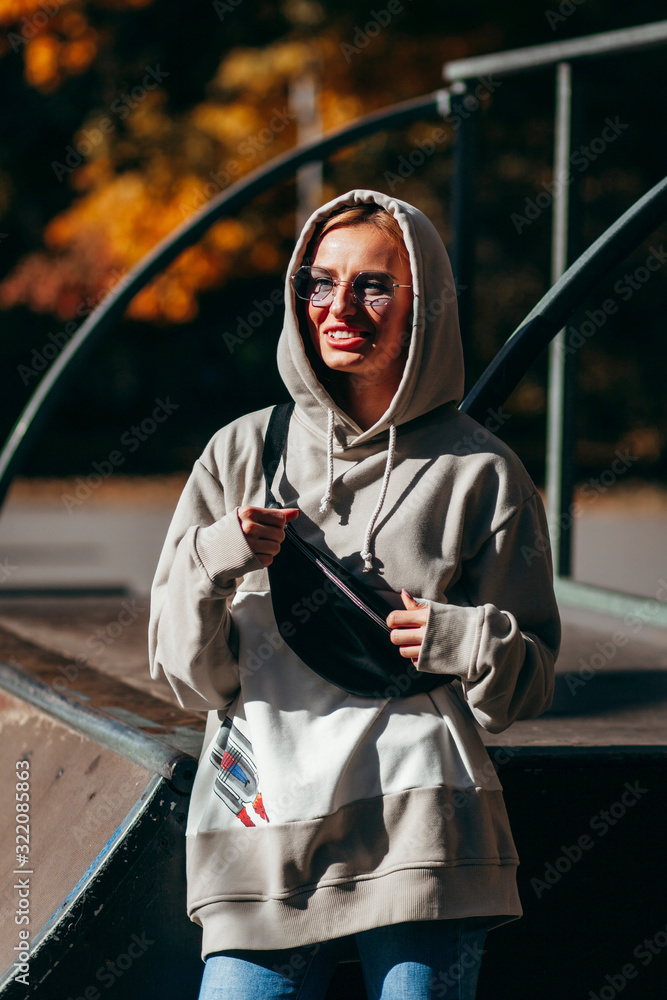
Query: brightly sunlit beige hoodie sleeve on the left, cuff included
[{"left": 149, "top": 461, "right": 261, "bottom": 710}]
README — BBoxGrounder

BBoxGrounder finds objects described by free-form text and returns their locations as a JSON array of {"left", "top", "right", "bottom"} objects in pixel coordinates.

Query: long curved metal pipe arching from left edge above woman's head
[{"left": 0, "top": 88, "right": 449, "bottom": 504}]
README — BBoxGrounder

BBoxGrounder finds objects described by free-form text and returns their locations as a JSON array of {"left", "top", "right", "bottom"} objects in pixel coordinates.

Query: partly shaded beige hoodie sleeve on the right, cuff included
[{"left": 417, "top": 493, "right": 560, "bottom": 733}]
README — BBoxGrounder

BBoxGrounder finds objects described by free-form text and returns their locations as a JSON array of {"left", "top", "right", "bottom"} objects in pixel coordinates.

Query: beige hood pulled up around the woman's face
[{"left": 278, "top": 188, "right": 463, "bottom": 449}]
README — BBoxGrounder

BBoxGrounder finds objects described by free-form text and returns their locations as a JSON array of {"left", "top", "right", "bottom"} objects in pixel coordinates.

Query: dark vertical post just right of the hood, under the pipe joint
[{"left": 451, "top": 83, "right": 475, "bottom": 371}]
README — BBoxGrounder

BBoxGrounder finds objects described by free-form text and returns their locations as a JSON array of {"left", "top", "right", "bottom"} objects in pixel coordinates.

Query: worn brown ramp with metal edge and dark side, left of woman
[{"left": 0, "top": 633, "right": 203, "bottom": 1000}]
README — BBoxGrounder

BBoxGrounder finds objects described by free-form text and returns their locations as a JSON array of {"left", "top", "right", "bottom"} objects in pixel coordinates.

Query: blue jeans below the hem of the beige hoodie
[{"left": 199, "top": 920, "right": 486, "bottom": 1000}]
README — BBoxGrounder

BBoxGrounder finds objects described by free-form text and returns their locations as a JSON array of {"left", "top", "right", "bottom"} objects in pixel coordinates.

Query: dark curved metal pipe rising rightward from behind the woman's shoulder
[{"left": 459, "top": 177, "right": 667, "bottom": 423}]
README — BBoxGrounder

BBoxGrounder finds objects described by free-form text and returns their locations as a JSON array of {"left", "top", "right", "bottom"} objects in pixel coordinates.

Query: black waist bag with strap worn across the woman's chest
[{"left": 262, "top": 403, "right": 454, "bottom": 699}]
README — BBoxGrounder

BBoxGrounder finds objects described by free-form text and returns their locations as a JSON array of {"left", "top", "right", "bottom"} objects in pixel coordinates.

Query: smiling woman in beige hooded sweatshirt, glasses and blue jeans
[{"left": 151, "top": 190, "right": 560, "bottom": 1000}]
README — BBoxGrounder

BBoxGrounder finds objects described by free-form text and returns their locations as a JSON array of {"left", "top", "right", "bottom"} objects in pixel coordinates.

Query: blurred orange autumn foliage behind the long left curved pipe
[{"left": 0, "top": 19, "right": 490, "bottom": 323}]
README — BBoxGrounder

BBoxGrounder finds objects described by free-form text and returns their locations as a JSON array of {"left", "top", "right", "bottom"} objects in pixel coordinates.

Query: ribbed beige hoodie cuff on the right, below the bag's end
[{"left": 417, "top": 598, "right": 484, "bottom": 680}]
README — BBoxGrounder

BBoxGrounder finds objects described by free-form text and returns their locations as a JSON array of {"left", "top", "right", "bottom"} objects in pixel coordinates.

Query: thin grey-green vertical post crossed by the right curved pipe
[{"left": 546, "top": 62, "right": 580, "bottom": 577}]
